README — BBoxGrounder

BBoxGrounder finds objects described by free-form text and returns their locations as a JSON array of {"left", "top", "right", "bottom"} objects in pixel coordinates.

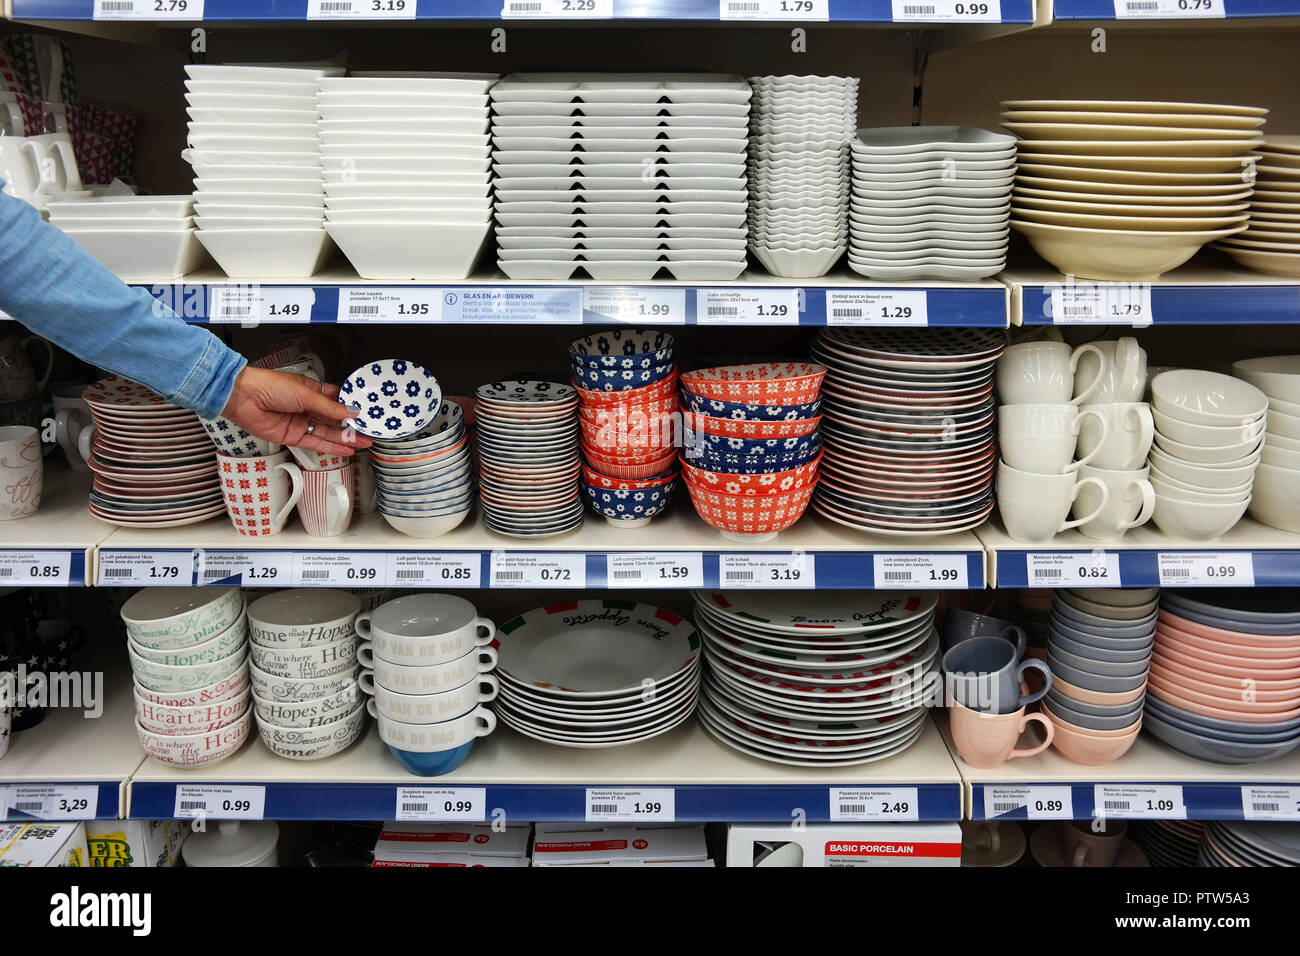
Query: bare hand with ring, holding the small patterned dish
[{"left": 221, "top": 365, "right": 371, "bottom": 455}]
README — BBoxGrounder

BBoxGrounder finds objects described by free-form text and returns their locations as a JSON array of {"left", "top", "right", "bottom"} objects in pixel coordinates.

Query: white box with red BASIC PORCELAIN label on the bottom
[{"left": 727, "top": 823, "right": 962, "bottom": 866}]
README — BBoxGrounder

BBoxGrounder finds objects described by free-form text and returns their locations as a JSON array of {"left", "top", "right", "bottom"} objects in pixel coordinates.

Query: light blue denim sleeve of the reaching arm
[{"left": 0, "top": 193, "right": 246, "bottom": 418}]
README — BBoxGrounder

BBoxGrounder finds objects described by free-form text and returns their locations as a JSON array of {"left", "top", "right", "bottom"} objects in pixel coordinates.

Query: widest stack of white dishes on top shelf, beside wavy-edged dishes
[{"left": 491, "top": 73, "right": 750, "bottom": 281}]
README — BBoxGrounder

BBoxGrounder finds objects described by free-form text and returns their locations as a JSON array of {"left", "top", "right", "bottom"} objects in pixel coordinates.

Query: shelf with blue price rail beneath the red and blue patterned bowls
[{"left": 96, "top": 506, "right": 985, "bottom": 589}]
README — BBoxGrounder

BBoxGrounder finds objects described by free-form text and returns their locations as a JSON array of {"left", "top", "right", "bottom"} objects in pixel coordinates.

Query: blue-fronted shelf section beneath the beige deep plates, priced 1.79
[{"left": 1000, "top": 252, "right": 1300, "bottom": 326}]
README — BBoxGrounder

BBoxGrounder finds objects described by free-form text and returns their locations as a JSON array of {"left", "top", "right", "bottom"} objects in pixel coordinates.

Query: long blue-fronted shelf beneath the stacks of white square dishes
[{"left": 137, "top": 264, "right": 1010, "bottom": 329}]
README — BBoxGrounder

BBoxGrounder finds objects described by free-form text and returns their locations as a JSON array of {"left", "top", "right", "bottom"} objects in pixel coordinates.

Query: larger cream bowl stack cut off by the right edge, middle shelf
[{"left": 1232, "top": 355, "right": 1300, "bottom": 532}]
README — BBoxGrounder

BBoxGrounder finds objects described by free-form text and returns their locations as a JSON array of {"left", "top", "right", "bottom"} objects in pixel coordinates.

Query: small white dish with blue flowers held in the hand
[{"left": 338, "top": 359, "right": 442, "bottom": 438}]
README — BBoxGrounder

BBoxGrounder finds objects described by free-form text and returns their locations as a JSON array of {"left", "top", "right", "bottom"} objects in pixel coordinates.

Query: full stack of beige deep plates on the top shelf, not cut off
[{"left": 1002, "top": 100, "right": 1269, "bottom": 281}]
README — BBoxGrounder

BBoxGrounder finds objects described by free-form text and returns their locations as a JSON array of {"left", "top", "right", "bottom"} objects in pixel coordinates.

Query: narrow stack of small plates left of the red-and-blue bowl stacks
[{"left": 475, "top": 380, "right": 582, "bottom": 537}]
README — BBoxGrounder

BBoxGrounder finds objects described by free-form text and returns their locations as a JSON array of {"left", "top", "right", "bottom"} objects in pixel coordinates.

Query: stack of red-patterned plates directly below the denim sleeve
[{"left": 82, "top": 375, "right": 225, "bottom": 528}]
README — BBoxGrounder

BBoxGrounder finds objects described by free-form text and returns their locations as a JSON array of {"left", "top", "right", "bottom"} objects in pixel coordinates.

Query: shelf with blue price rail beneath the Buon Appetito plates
[{"left": 130, "top": 721, "right": 962, "bottom": 822}]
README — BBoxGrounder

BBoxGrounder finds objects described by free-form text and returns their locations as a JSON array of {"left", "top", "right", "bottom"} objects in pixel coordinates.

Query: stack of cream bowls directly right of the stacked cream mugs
[{"left": 1149, "top": 368, "right": 1269, "bottom": 541}]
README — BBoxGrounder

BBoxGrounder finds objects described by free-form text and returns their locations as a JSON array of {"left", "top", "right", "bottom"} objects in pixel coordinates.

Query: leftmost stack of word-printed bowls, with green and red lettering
[{"left": 122, "top": 588, "right": 251, "bottom": 767}]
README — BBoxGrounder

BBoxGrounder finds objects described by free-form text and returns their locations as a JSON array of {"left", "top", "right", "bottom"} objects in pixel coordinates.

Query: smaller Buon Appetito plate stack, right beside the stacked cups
[{"left": 497, "top": 601, "right": 699, "bottom": 749}]
